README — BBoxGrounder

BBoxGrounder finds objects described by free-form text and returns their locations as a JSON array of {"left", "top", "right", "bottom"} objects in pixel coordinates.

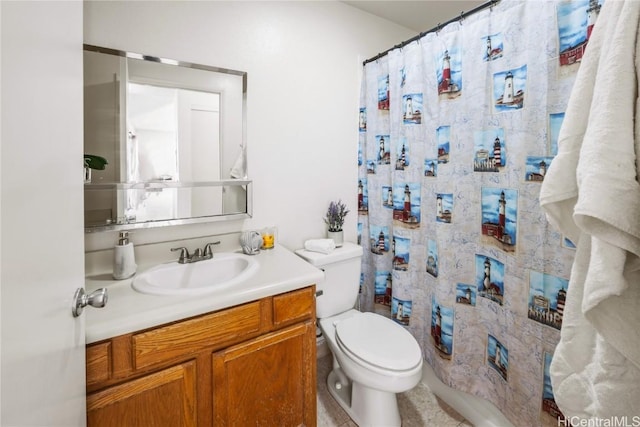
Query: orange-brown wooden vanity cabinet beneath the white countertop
[{"left": 87, "top": 286, "right": 316, "bottom": 427}]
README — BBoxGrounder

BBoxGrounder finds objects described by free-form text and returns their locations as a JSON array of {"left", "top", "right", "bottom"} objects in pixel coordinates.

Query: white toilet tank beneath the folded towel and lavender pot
[{"left": 296, "top": 242, "right": 362, "bottom": 319}]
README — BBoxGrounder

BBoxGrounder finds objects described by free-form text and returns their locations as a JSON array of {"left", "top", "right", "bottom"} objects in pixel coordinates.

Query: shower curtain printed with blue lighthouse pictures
[{"left": 358, "top": 0, "right": 602, "bottom": 426}]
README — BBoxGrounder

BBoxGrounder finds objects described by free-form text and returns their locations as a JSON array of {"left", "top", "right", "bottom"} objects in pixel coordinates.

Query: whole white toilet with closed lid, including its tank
[{"left": 296, "top": 242, "right": 422, "bottom": 427}]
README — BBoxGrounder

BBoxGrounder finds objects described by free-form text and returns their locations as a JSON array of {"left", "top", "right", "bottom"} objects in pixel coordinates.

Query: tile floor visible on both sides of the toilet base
[{"left": 317, "top": 354, "right": 472, "bottom": 427}]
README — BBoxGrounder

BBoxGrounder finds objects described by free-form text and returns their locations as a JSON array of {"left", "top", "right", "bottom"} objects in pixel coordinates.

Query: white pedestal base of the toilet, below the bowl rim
[{"left": 327, "top": 367, "right": 402, "bottom": 427}]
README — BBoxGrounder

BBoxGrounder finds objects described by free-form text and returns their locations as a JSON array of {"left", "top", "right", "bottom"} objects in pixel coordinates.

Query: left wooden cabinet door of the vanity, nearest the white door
[{"left": 87, "top": 361, "right": 197, "bottom": 427}]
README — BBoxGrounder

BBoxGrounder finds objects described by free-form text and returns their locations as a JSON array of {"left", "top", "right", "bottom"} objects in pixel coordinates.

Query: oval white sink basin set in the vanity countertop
[{"left": 131, "top": 253, "right": 259, "bottom": 295}]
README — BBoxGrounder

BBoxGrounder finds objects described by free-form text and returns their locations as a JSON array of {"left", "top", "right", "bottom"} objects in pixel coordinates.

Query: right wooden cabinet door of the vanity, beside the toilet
[{"left": 213, "top": 321, "right": 316, "bottom": 427}]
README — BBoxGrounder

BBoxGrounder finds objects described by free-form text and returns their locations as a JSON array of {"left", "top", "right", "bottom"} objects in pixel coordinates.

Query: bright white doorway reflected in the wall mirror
[{"left": 127, "top": 83, "right": 222, "bottom": 182}]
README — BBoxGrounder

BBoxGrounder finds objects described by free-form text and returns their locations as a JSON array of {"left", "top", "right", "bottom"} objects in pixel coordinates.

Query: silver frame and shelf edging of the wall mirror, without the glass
[{"left": 82, "top": 43, "right": 253, "bottom": 233}]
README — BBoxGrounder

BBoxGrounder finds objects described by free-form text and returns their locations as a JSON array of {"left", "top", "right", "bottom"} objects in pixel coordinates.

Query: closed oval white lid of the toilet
[{"left": 336, "top": 313, "right": 422, "bottom": 371}]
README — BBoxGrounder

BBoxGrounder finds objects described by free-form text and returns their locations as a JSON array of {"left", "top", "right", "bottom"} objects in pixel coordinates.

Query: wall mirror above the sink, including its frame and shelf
[{"left": 83, "top": 44, "right": 252, "bottom": 232}]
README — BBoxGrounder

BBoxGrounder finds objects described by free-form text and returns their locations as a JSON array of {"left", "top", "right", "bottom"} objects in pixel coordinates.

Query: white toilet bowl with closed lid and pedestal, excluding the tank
[{"left": 319, "top": 310, "right": 422, "bottom": 427}]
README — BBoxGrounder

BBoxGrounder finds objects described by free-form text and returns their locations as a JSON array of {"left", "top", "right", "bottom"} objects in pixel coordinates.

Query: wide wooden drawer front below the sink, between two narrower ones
[{"left": 131, "top": 301, "right": 261, "bottom": 369}]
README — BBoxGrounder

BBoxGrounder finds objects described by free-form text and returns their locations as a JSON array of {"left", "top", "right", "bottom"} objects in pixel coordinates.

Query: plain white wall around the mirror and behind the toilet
[{"left": 84, "top": 1, "right": 415, "bottom": 250}]
